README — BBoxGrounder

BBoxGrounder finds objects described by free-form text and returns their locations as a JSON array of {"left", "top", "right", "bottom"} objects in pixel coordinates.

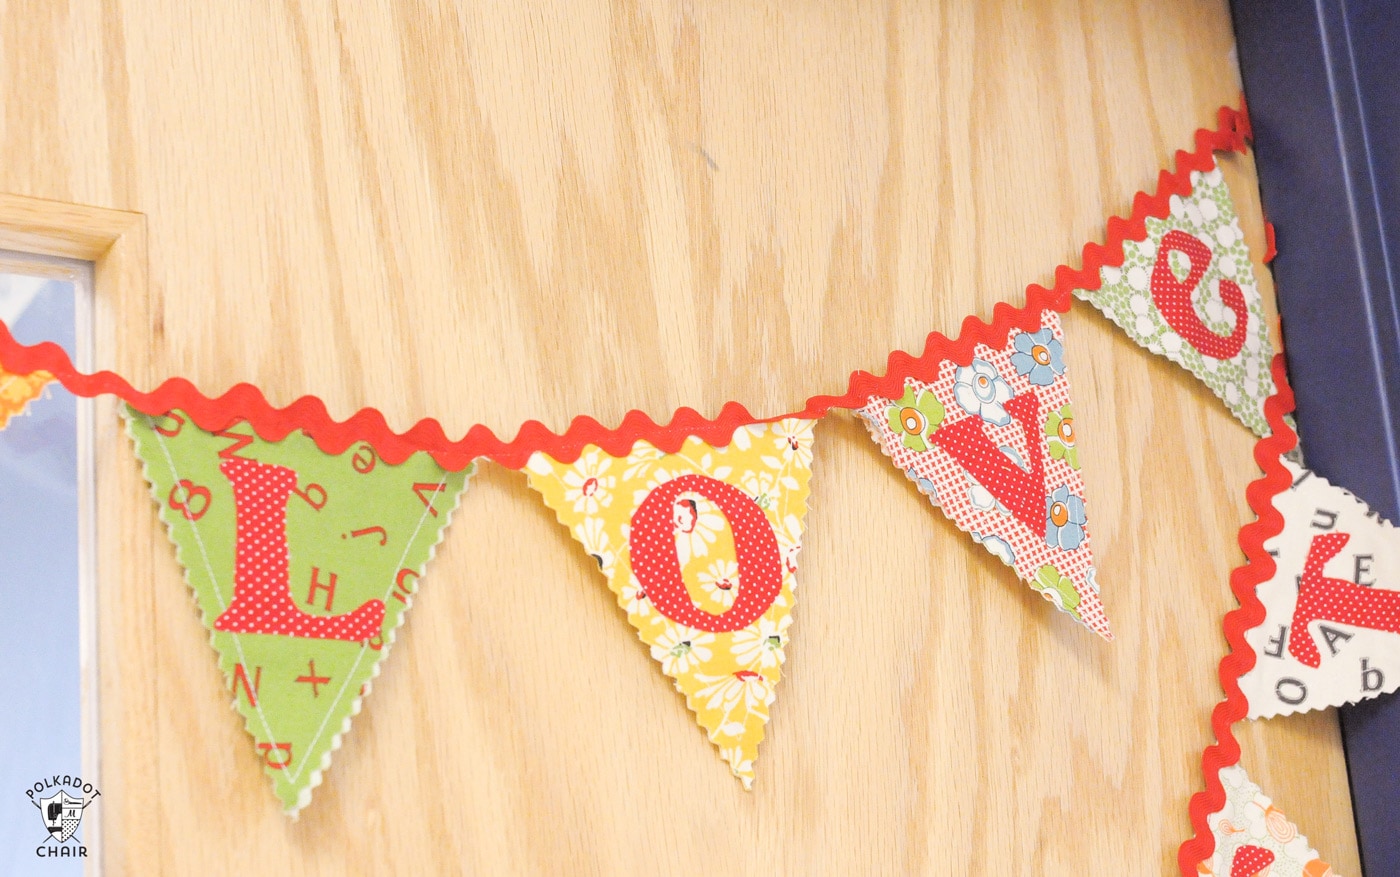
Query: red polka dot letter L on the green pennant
[{"left": 214, "top": 457, "right": 384, "bottom": 642}]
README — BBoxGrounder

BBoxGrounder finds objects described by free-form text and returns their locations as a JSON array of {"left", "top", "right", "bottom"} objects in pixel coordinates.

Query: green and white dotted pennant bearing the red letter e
[{"left": 1074, "top": 159, "right": 1274, "bottom": 436}]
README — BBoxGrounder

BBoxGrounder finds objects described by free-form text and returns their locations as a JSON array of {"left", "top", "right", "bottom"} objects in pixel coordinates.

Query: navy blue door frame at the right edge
[{"left": 1233, "top": 0, "right": 1400, "bottom": 876}]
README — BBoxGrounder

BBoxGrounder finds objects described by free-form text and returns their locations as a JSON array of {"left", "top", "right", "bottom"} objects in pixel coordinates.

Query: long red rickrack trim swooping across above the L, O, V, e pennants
[{"left": 0, "top": 106, "right": 1249, "bottom": 471}]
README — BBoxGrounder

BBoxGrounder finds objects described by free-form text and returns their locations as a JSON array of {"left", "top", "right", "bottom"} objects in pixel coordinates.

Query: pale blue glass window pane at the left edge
[{"left": 0, "top": 263, "right": 95, "bottom": 874}]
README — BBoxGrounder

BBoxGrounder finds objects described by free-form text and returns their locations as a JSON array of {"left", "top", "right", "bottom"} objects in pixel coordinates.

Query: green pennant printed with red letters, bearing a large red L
[{"left": 127, "top": 409, "right": 472, "bottom": 814}]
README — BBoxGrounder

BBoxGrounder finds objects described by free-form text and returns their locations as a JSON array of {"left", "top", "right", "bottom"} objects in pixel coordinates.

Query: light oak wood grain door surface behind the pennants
[{"left": 0, "top": 0, "right": 1359, "bottom": 874}]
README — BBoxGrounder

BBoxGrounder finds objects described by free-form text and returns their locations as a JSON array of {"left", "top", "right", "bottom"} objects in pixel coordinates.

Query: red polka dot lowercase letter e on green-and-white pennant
[{"left": 1152, "top": 228, "right": 1249, "bottom": 359}]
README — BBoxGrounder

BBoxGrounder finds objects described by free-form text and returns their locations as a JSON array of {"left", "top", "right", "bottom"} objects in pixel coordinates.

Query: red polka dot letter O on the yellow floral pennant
[{"left": 627, "top": 475, "right": 783, "bottom": 633}]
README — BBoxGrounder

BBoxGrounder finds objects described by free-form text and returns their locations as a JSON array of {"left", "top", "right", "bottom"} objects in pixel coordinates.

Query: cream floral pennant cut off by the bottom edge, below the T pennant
[{"left": 1196, "top": 765, "right": 1336, "bottom": 877}]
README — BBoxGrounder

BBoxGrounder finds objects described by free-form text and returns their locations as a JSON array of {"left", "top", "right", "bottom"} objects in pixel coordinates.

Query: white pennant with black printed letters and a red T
[{"left": 1239, "top": 460, "right": 1400, "bottom": 719}]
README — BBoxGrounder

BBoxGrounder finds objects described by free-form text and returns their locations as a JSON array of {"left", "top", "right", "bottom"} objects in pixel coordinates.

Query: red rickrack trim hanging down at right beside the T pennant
[{"left": 1176, "top": 353, "right": 1298, "bottom": 877}]
